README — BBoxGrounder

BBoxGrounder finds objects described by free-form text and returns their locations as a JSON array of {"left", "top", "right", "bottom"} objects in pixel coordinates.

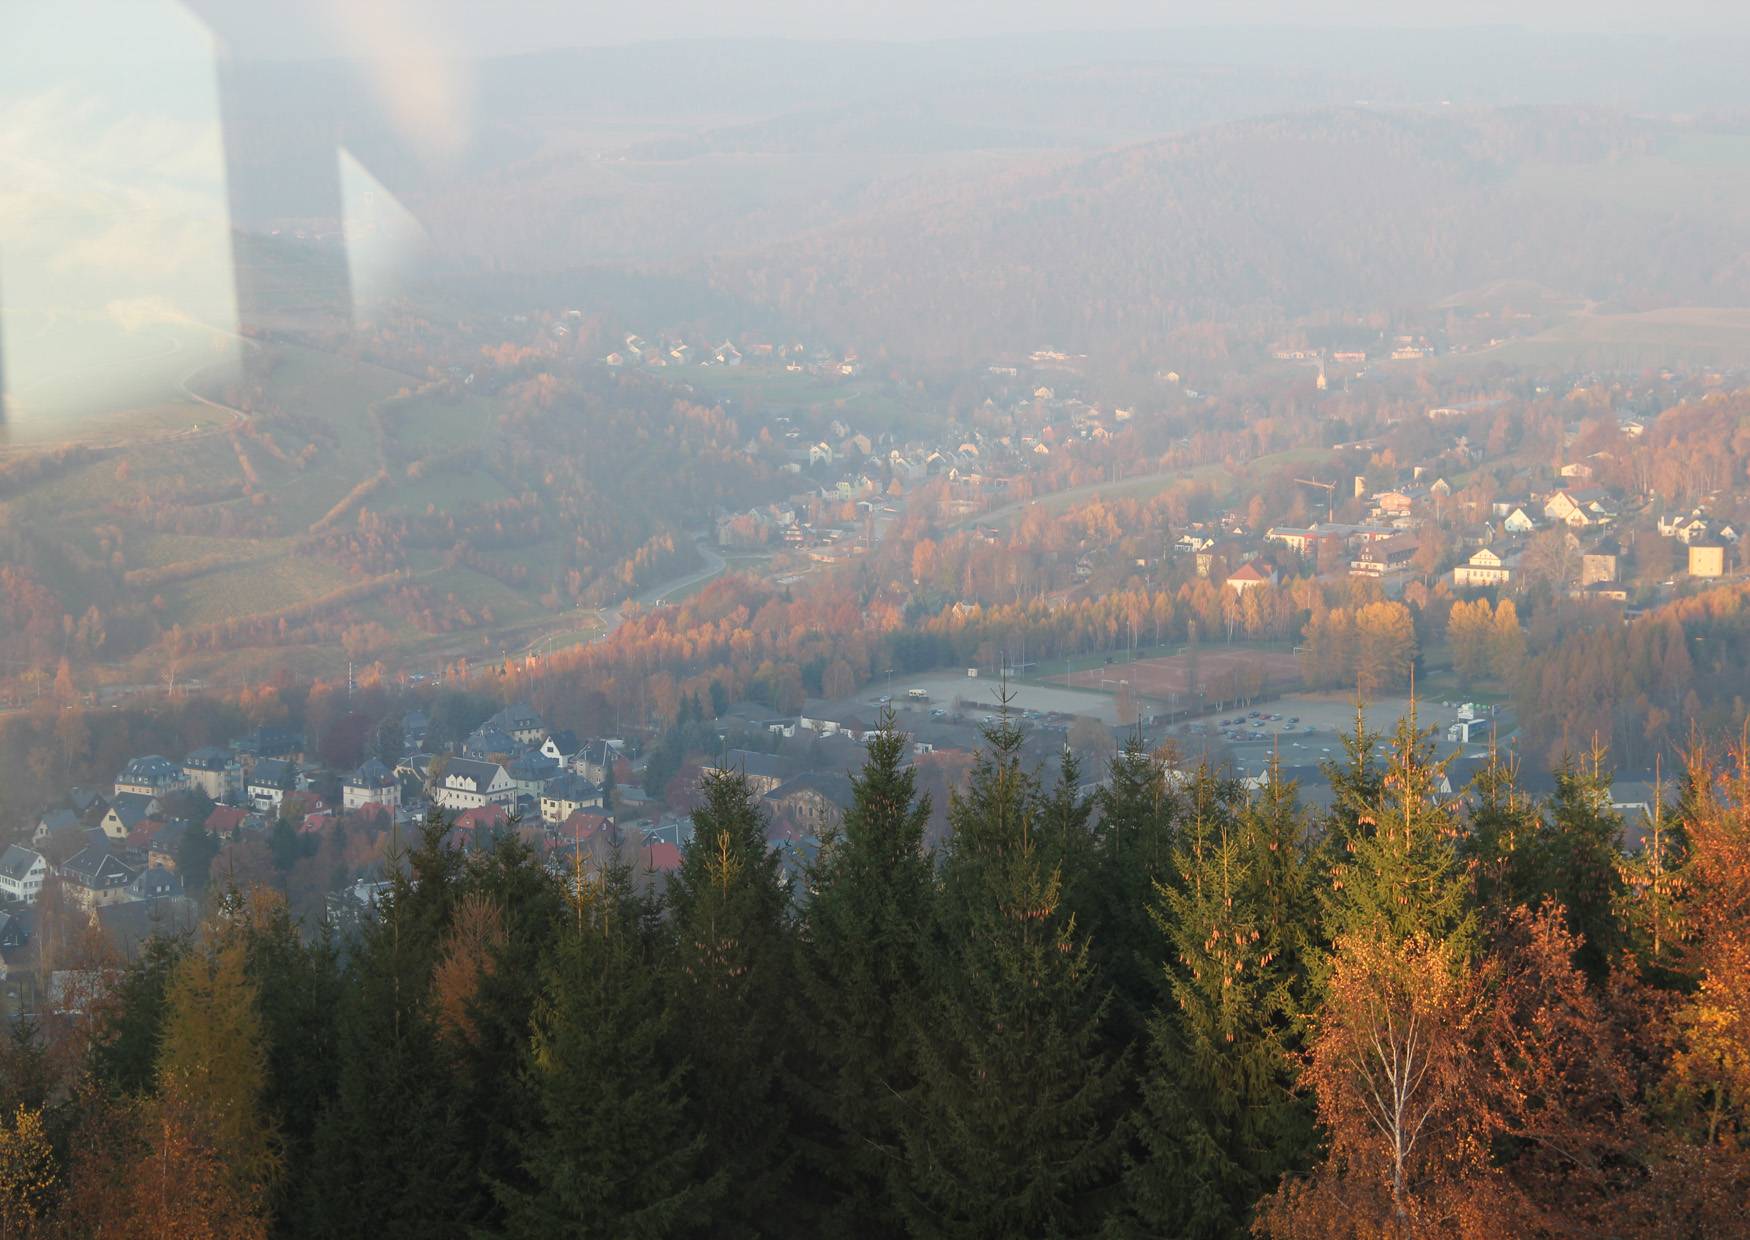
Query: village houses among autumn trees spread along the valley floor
[{"left": 0, "top": 317, "right": 1745, "bottom": 993}]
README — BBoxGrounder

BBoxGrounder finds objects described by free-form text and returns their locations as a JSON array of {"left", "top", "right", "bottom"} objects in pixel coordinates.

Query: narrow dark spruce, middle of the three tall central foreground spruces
[{"left": 798, "top": 712, "right": 933, "bottom": 1233}]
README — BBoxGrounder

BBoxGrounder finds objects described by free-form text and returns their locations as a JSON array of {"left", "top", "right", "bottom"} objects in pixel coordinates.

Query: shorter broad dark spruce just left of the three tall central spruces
[{"left": 499, "top": 864, "right": 723, "bottom": 1240}]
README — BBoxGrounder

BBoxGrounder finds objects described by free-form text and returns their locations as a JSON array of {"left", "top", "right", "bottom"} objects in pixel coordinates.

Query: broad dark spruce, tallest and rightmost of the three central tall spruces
[{"left": 901, "top": 710, "right": 1120, "bottom": 1237}]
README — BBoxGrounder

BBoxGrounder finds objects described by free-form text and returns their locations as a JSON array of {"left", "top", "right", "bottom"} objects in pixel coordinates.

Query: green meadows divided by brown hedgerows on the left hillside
[{"left": 4, "top": 338, "right": 600, "bottom": 684}]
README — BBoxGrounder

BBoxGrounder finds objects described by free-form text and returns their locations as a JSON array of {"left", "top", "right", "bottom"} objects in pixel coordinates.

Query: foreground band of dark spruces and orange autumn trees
[{"left": 0, "top": 717, "right": 1750, "bottom": 1237}]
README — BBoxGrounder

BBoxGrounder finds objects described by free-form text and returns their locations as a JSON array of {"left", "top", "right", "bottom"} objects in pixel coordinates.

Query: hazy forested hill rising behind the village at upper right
[{"left": 712, "top": 108, "right": 1750, "bottom": 360}]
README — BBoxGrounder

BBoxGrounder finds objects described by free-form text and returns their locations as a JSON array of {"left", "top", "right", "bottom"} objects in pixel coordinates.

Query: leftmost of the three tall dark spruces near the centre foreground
[{"left": 669, "top": 771, "right": 795, "bottom": 1237}]
